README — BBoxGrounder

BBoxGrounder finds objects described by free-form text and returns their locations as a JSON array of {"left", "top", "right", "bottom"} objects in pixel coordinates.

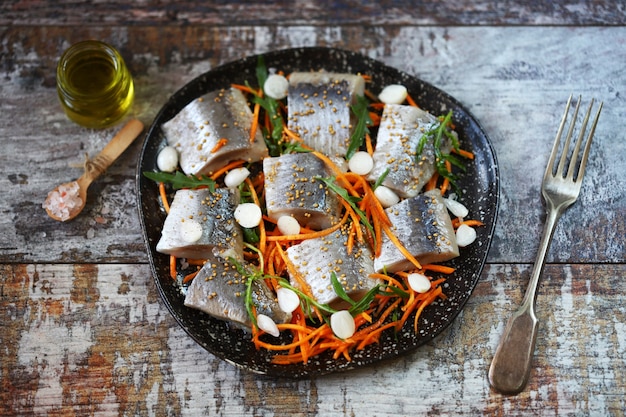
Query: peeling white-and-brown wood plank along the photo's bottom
[{"left": 0, "top": 264, "right": 626, "bottom": 416}]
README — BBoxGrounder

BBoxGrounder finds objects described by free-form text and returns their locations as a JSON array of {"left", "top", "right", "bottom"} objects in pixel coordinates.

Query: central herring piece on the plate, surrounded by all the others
[{"left": 263, "top": 153, "right": 341, "bottom": 230}]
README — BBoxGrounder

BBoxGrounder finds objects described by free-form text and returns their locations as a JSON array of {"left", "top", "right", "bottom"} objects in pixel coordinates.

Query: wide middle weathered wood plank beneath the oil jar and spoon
[{"left": 0, "top": 26, "right": 626, "bottom": 263}]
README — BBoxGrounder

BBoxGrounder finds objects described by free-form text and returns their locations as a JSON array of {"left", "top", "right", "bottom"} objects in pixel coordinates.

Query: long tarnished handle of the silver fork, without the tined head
[{"left": 489, "top": 207, "right": 564, "bottom": 394}]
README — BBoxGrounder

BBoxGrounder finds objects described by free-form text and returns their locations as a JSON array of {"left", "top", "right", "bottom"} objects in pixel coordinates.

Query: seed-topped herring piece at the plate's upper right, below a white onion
[{"left": 368, "top": 104, "right": 450, "bottom": 198}]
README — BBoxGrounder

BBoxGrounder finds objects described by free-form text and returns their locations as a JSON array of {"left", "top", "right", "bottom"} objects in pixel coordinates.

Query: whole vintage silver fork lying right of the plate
[{"left": 489, "top": 96, "right": 603, "bottom": 394}]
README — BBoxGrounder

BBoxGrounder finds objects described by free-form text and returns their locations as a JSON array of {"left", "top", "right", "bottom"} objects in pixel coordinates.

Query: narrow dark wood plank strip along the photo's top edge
[{"left": 0, "top": 0, "right": 625, "bottom": 27}]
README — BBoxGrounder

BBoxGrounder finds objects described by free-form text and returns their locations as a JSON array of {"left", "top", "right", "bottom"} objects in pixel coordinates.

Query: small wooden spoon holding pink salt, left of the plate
[{"left": 43, "top": 119, "right": 143, "bottom": 222}]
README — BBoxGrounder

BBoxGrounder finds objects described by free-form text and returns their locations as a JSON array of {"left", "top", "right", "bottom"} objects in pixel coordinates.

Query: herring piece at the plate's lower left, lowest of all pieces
[{"left": 185, "top": 253, "right": 291, "bottom": 328}]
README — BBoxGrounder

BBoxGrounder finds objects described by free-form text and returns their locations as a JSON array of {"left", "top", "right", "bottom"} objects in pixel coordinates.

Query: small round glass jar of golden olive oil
[{"left": 57, "top": 40, "right": 135, "bottom": 128}]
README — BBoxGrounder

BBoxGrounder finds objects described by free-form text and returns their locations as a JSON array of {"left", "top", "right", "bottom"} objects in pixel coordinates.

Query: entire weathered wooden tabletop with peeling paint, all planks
[{"left": 0, "top": 0, "right": 626, "bottom": 416}]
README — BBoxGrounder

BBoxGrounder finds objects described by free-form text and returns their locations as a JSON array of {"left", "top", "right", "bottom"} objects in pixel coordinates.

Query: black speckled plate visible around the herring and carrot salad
[{"left": 137, "top": 48, "right": 499, "bottom": 378}]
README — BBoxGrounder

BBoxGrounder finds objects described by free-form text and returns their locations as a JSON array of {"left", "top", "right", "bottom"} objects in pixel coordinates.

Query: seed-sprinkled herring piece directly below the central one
[{"left": 287, "top": 226, "right": 380, "bottom": 308}]
